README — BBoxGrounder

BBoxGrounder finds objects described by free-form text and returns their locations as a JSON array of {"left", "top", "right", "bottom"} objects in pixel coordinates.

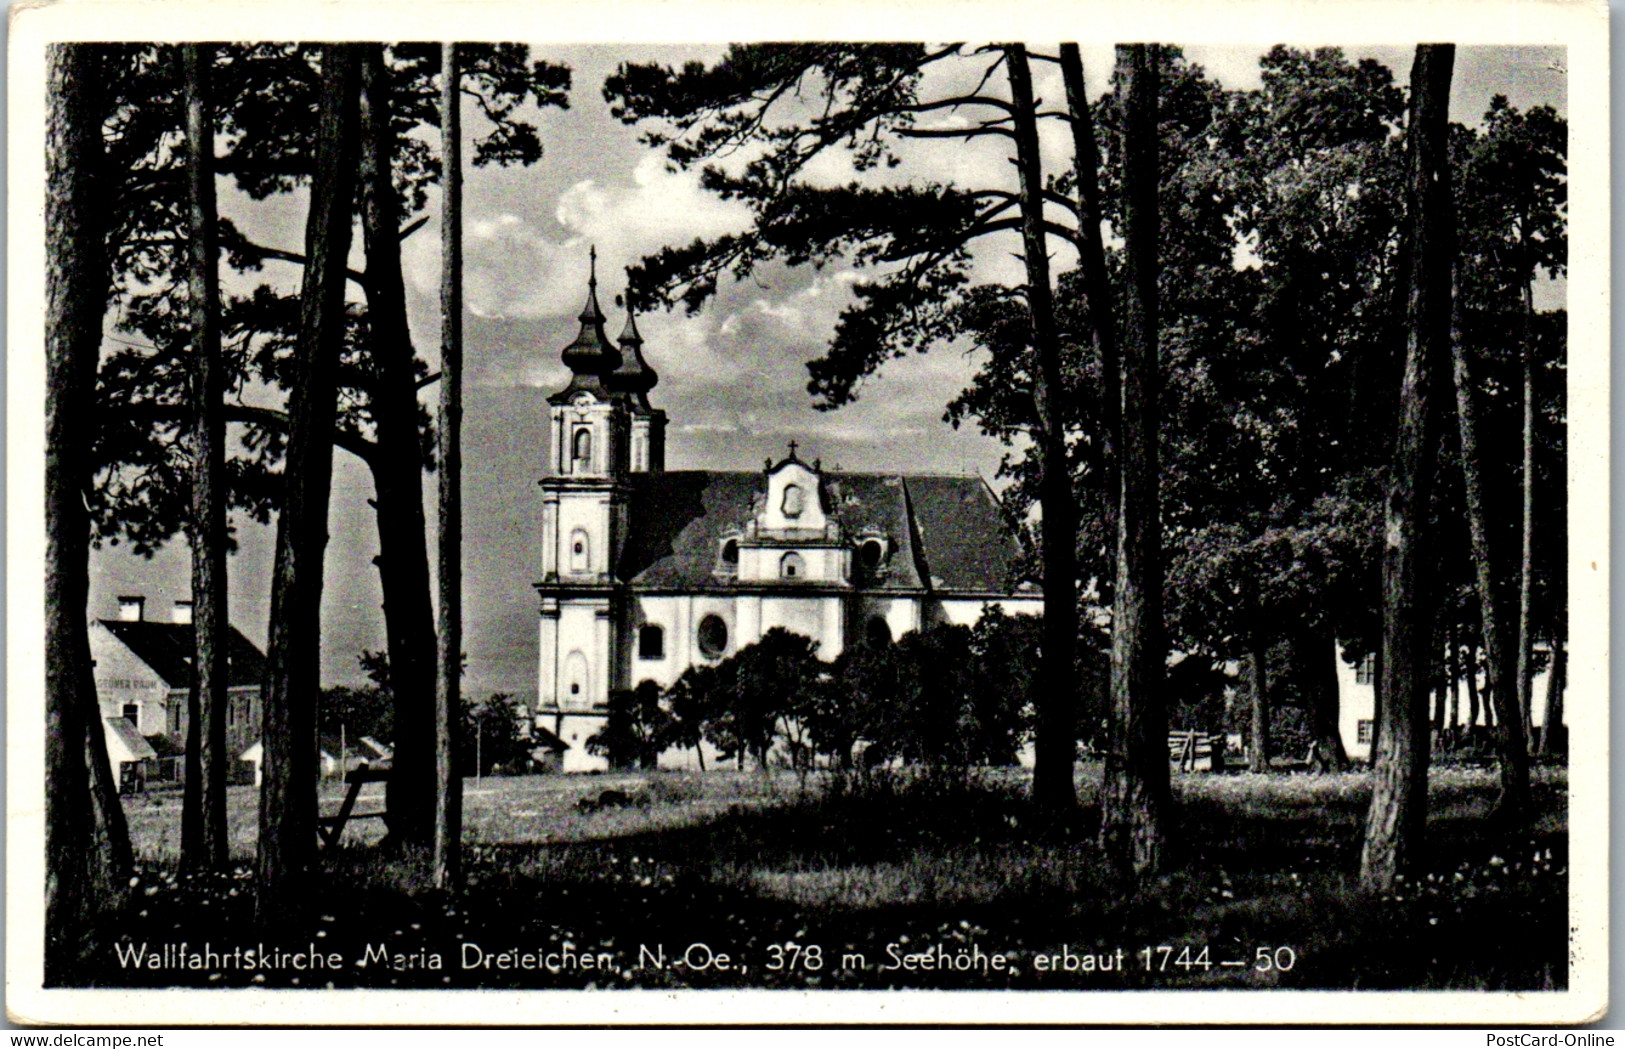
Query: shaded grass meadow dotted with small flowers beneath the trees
[{"left": 75, "top": 765, "right": 1568, "bottom": 991}]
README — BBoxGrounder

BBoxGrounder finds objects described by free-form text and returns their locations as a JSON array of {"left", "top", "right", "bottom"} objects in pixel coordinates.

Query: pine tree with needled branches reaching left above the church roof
[{"left": 605, "top": 44, "right": 1105, "bottom": 807}]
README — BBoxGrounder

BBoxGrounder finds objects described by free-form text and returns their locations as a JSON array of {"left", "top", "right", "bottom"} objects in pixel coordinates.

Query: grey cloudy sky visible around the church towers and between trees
[{"left": 91, "top": 45, "right": 1567, "bottom": 697}]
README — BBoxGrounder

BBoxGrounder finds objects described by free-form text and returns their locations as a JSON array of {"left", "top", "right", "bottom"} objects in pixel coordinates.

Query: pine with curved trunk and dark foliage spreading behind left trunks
[{"left": 96, "top": 44, "right": 569, "bottom": 843}]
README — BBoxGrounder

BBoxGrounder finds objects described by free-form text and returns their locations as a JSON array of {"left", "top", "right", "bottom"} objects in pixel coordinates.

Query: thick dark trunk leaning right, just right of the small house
[{"left": 255, "top": 44, "right": 358, "bottom": 924}]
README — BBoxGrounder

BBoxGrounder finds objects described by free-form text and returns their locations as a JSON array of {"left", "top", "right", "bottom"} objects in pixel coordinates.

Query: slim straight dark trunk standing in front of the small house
[{"left": 180, "top": 44, "right": 231, "bottom": 870}]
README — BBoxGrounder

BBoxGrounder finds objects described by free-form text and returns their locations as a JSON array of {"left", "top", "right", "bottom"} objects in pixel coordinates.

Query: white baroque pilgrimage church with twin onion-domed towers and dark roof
[{"left": 535, "top": 258, "right": 1043, "bottom": 771}]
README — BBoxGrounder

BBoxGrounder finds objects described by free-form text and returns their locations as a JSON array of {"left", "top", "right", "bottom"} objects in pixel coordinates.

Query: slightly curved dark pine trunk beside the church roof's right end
[{"left": 1004, "top": 44, "right": 1077, "bottom": 810}]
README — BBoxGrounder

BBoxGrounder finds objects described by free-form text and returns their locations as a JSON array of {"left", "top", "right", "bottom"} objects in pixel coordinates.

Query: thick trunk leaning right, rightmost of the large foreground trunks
[{"left": 1360, "top": 44, "right": 1456, "bottom": 891}]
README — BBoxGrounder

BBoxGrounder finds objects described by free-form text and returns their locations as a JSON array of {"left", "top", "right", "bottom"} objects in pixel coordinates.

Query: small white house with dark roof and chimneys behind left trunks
[{"left": 89, "top": 596, "right": 265, "bottom": 785}]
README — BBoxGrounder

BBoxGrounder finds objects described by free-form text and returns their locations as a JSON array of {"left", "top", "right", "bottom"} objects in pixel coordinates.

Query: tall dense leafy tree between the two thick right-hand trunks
[{"left": 1164, "top": 47, "right": 1402, "bottom": 768}]
